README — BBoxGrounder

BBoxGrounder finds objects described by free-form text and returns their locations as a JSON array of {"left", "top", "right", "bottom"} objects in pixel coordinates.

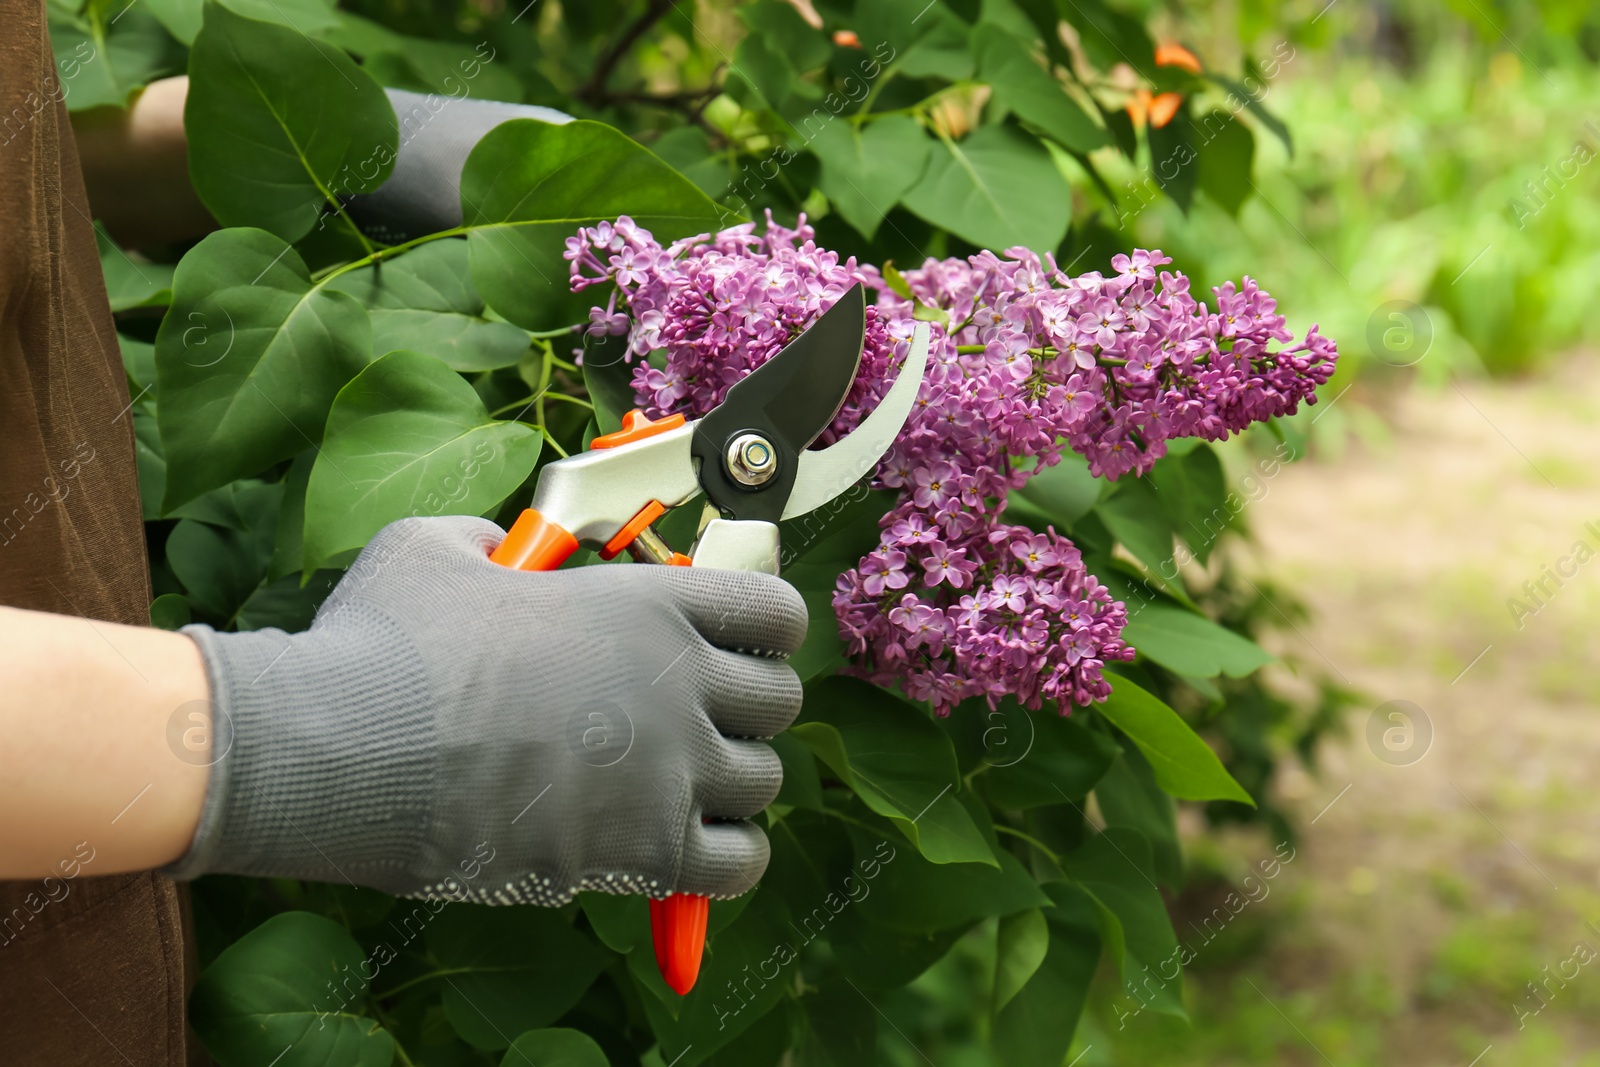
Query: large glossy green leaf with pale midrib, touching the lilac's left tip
[{"left": 461, "top": 118, "right": 726, "bottom": 330}]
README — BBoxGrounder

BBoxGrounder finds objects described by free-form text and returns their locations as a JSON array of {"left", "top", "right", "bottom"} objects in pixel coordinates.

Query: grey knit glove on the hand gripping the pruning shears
[{"left": 168, "top": 517, "right": 806, "bottom": 904}]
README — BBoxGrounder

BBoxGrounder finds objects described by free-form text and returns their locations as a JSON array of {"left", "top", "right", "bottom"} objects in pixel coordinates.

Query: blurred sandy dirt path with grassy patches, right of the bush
[{"left": 1120, "top": 365, "right": 1600, "bottom": 1067}]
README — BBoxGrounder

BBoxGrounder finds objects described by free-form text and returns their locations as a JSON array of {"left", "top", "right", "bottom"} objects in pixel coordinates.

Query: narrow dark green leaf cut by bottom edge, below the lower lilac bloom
[{"left": 992, "top": 881, "right": 1101, "bottom": 1067}]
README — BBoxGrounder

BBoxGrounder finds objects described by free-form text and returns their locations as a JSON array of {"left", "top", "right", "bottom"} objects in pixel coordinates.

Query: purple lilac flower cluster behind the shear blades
[{"left": 566, "top": 216, "right": 1338, "bottom": 713}]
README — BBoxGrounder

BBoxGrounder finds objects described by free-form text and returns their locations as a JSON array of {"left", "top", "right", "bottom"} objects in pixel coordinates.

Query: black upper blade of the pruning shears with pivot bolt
[{"left": 693, "top": 283, "right": 867, "bottom": 523}]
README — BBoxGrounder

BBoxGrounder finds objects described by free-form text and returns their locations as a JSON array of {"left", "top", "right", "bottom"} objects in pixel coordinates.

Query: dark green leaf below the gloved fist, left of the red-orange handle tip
[{"left": 426, "top": 904, "right": 611, "bottom": 1049}]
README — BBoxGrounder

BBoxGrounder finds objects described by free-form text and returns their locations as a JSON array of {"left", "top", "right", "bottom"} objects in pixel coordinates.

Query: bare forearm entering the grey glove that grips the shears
[{"left": 0, "top": 608, "right": 211, "bottom": 878}]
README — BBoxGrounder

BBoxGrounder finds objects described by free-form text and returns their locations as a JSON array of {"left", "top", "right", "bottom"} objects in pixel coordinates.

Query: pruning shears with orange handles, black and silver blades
[{"left": 490, "top": 283, "right": 928, "bottom": 993}]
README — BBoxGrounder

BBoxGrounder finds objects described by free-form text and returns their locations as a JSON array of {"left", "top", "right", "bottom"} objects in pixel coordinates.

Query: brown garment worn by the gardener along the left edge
[{"left": 0, "top": 0, "right": 194, "bottom": 1067}]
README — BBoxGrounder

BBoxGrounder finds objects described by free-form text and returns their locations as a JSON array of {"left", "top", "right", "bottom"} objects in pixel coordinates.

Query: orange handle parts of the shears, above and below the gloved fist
[{"left": 490, "top": 506, "right": 710, "bottom": 997}]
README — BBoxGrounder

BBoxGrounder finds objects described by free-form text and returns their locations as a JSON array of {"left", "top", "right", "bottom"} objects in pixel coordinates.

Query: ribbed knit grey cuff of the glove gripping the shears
[{"left": 162, "top": 605, "right": 438, "bottom": 885}]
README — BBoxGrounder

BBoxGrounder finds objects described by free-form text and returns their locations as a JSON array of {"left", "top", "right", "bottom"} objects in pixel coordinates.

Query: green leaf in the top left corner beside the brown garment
[{"left": 50, "top": 0, "right": 184, "bottom": 111}]
